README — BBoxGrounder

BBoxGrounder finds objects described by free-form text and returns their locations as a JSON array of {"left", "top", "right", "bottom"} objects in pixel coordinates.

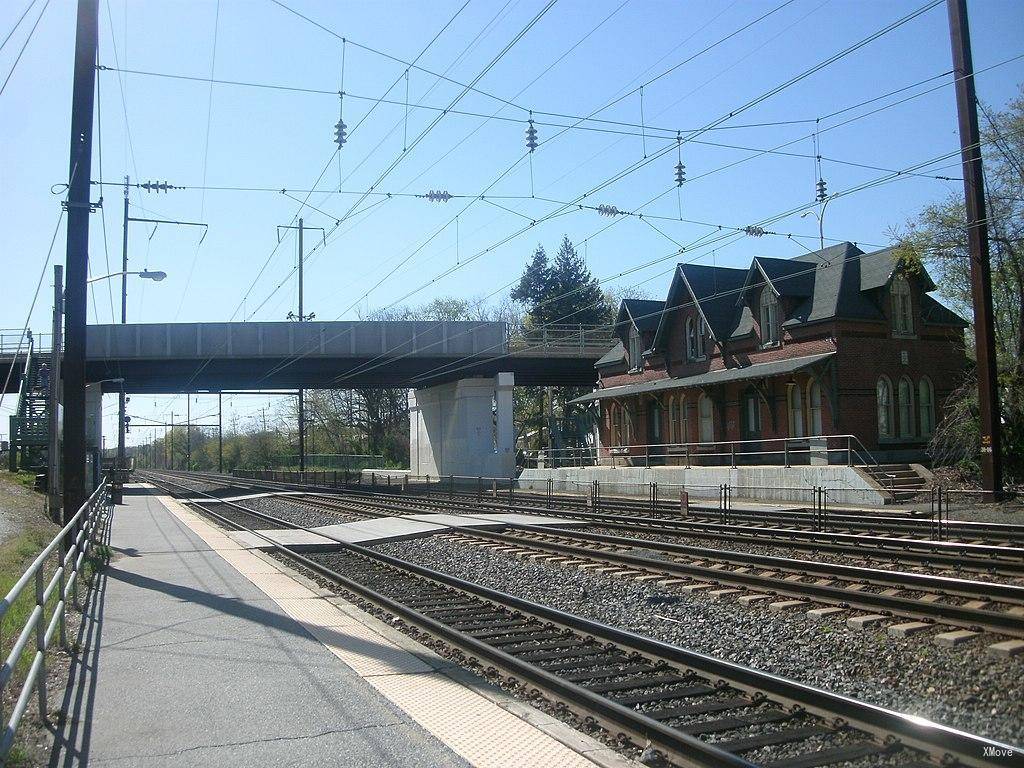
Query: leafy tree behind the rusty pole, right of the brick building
[{"left": 897, "top": 90, "right": 1024, "bottom": 482}]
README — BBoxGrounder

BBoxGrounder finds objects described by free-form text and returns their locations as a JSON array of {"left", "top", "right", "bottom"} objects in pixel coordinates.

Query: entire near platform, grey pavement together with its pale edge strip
[{"left": 50, "top": 486, "right": 627, "bottom": 768}]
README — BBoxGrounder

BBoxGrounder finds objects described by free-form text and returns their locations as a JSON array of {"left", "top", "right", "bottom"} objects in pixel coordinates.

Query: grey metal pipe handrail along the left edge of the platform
[{"left": 0, "top": 479, "right": 111, "bottom": 761}]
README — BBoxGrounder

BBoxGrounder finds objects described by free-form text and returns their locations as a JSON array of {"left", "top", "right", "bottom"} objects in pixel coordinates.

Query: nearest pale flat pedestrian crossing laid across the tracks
[{"left": 227, "top": 512, "right": 587, "bottom": 551}]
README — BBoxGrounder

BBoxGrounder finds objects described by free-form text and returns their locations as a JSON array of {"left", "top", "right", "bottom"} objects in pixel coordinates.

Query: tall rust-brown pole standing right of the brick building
[{"left": 946, "top": 0, "right": 1002, "bottom": 500}]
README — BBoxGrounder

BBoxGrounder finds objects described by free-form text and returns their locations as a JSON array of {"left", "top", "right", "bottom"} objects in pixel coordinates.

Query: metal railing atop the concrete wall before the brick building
[{"left": 525, "top": 434, "right": 879, "bottom": 468}]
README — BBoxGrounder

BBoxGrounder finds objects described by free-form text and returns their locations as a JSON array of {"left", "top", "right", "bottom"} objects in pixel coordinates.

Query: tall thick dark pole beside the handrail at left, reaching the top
[{"left": 63, "top": 0, "right": 99, "bottom": 536}]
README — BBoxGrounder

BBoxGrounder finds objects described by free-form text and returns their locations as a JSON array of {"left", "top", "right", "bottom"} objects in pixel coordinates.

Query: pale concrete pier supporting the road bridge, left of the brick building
[{"left": 409, "top": 373, "right": 515, "bottom": 477}]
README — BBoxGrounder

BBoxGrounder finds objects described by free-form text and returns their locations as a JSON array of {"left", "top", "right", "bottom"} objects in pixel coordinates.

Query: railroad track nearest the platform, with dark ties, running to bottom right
[{"left": 145, "top": 474, "right": 1024, "bottom": 768}]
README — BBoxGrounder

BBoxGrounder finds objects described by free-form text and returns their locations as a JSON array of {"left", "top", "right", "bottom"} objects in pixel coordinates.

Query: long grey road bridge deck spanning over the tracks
[{"left": 0, "top": 322, "right": 612, "bottom": 394}]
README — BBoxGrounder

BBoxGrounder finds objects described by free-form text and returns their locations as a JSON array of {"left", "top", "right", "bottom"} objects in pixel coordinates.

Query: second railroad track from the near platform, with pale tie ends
[{"left": 226, "top": 481, "right": 1024, "bottom": 637}]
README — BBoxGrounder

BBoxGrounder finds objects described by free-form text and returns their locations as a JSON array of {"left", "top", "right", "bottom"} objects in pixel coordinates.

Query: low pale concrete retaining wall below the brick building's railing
[{"left": 519, "top": 465, "right": 887, "bottom": 507}]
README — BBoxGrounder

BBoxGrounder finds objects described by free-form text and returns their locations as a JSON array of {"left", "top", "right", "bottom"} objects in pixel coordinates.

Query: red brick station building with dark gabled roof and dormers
[{"left": 578, "top": 243, "right": 967, "bottom": 465}]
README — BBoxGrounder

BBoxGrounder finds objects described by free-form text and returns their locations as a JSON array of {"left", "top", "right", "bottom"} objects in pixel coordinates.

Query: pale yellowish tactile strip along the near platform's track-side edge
[{"left": 158, "top": 496, "right": 636, "bottom": 768}]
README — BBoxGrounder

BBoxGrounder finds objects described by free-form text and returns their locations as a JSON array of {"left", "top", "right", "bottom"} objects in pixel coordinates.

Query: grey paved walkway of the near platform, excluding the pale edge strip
[{"left": 51, "top": 488, "right": 468, "bottom": 768}]
